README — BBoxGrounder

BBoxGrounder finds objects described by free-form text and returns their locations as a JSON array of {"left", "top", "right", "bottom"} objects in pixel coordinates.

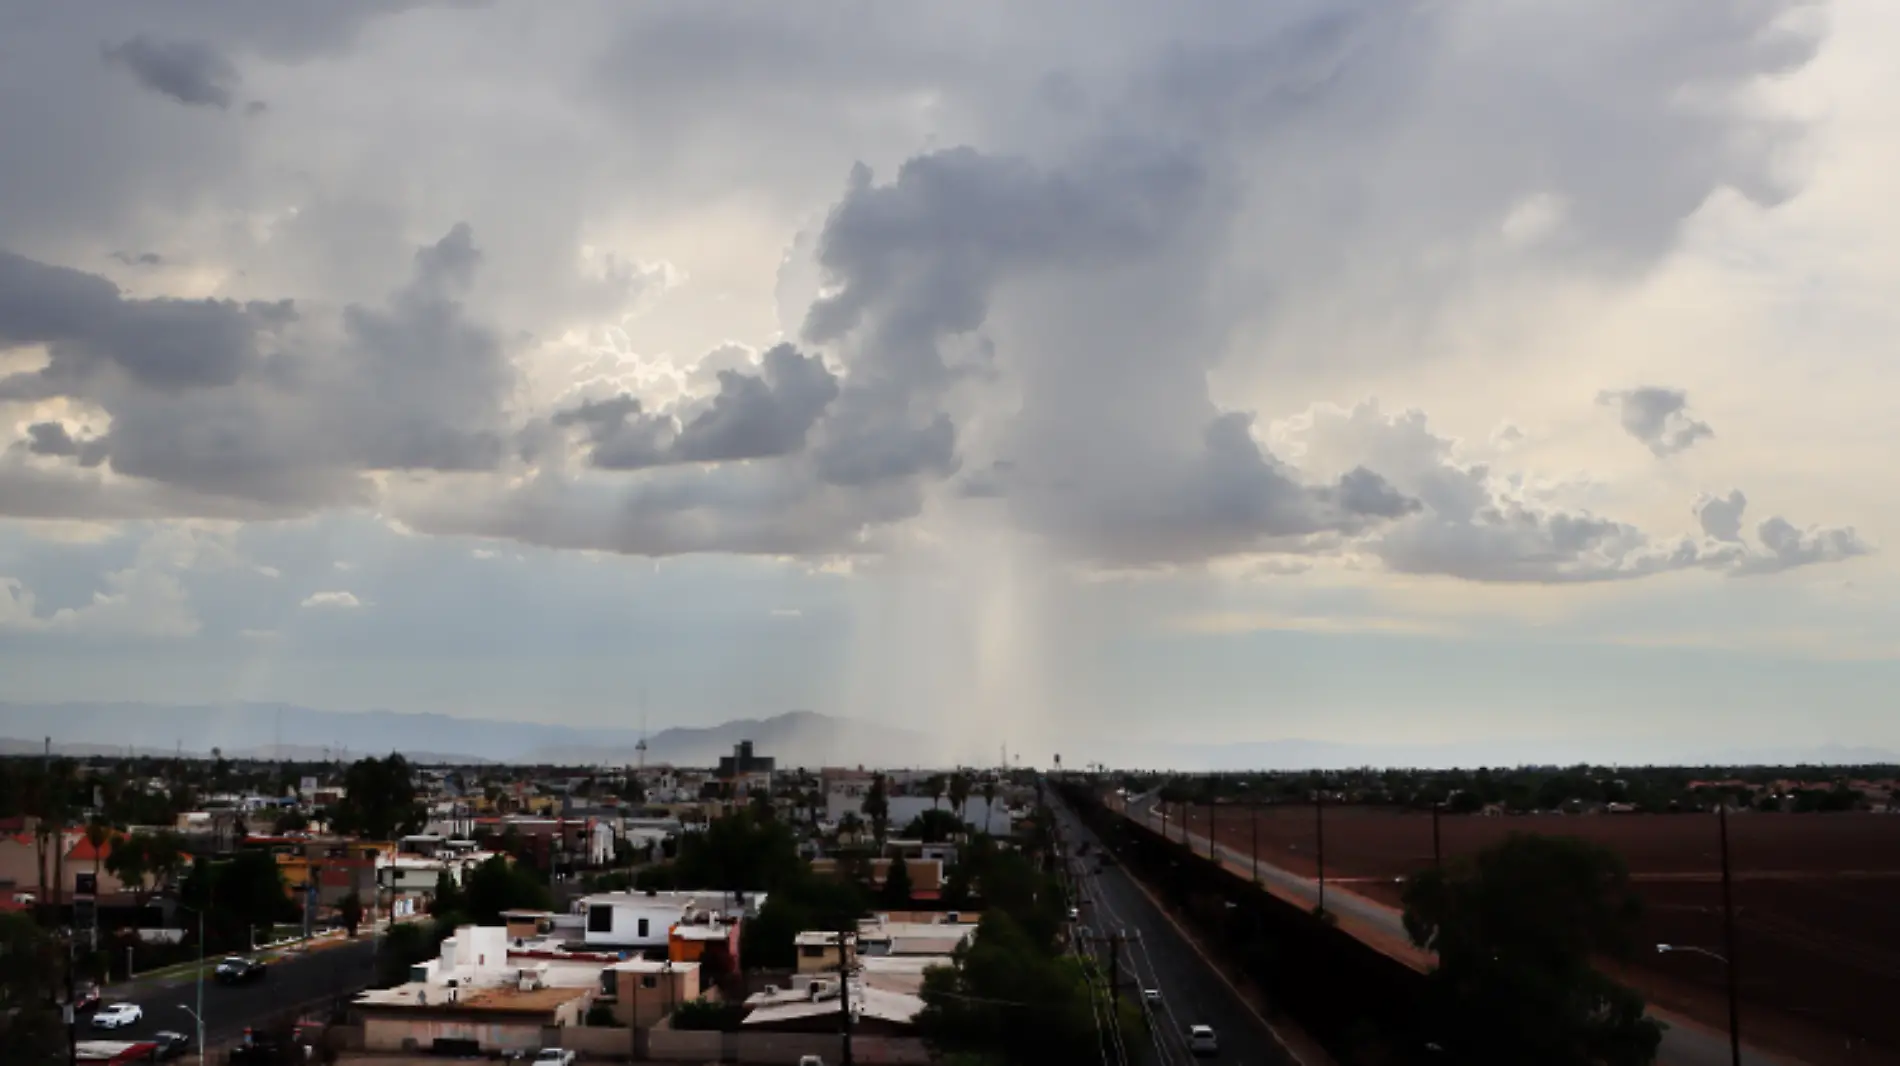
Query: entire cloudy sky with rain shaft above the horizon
[{"left": 0, "top": 0, "right": 1900, "bottom": 762}]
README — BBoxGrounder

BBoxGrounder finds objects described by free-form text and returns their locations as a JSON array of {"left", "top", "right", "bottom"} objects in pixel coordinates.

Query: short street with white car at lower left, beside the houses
[{"left": 80, "top": 937, "right": 374, "bottom": 1047}]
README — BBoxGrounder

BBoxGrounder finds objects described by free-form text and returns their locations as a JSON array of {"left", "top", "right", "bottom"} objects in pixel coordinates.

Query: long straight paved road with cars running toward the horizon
[{"left": 1056, "top": 808, "right": 1294, "bottom": 1066}]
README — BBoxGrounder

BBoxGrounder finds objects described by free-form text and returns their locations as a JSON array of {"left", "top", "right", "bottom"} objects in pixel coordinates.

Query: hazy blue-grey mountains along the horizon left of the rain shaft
[{"left": 0, "top": 703, "right": 946, "bottom": 766}]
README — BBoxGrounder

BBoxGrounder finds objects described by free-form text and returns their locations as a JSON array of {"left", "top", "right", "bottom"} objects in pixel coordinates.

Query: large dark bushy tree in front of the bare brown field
[{"left": 1404, "top": 834, "right": 1663, "bottom": 1066}]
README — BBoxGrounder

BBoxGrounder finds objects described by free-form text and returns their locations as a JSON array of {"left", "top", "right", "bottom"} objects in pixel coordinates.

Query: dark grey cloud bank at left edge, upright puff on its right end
[{"left": 0, "top": 226, "right": 515, "bottom": 517}]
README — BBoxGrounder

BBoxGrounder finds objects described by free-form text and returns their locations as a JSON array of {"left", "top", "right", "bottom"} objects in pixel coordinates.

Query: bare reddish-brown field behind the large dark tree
[{"left": 1169, "top": 806, "right": 1900, "bottom": 1066}]
